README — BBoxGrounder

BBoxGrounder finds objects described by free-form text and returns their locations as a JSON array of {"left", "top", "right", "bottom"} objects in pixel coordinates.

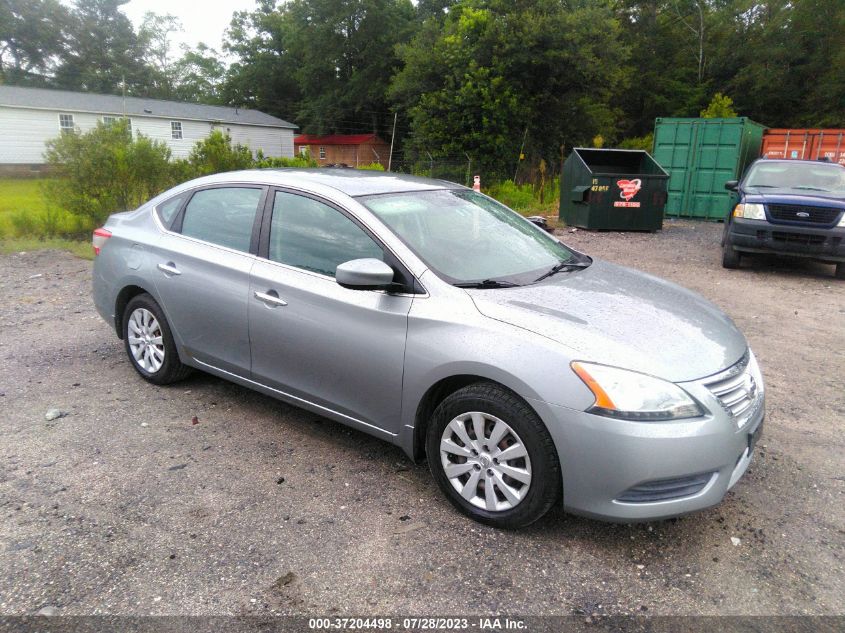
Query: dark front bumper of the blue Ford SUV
[{"left": 728, "top": 218, "right": 845, "bottom": 262}]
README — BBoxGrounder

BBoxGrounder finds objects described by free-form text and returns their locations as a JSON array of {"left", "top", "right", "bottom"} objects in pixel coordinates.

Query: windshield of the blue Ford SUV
[{"left": 743, "top": 161, "right": 845, "bottom": 195}]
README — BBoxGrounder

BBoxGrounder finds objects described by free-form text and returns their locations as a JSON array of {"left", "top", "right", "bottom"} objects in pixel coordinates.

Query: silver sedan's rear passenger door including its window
[{"left": 153, "top": 185, "right": 267, "bottom": 376}]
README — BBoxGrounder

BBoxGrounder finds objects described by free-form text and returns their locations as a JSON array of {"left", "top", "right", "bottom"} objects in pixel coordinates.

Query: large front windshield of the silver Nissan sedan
[{"left": 359, "top": 190, "right": 581, "bottom": 284}]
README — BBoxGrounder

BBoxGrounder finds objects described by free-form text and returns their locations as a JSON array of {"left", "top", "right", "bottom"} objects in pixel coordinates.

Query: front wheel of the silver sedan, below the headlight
[{"left": 426, "top": 383, "right": 561, "bottom": 528}]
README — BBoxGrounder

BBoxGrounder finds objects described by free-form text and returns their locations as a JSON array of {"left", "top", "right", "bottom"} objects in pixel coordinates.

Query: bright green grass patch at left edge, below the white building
[{"left": 0, "top": 178, "right": 89, "bottom": 239}]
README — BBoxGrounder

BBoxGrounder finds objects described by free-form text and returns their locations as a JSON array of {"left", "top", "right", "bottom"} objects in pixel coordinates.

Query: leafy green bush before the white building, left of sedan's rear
[{"left": 45, "top": 122, "right": 172, "bottom": 228}]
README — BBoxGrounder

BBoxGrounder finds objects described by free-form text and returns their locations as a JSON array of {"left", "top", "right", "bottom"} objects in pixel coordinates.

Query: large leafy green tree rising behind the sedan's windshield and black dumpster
[{"left": 391, "top": 0, "right": 630, "bottom": 177}]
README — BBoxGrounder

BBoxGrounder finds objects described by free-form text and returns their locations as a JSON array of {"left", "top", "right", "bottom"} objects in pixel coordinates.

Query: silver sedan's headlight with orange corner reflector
[{"left": 572, "top": 362, "right": 704, "bottom": 421}]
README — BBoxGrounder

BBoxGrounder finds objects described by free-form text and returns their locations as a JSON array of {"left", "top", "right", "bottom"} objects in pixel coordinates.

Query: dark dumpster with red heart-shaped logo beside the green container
[{"left": 560, "top": 147, "right": 669, "bottom": 231}]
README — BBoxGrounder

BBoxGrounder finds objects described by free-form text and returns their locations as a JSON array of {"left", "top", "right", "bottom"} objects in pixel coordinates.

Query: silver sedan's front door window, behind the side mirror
[{"left": 268, "top": 191, "right": 384, "bottom": 277}]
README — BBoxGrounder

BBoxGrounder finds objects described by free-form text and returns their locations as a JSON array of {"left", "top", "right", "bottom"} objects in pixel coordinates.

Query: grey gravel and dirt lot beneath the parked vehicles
[{"left": 0, "top": 222, "right": 845, "bottom": 615}]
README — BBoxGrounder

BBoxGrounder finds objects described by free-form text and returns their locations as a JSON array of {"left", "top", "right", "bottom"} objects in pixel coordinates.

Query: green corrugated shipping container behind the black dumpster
[{"left": 654, "top": 117, "right": 766, "bottom": 220}]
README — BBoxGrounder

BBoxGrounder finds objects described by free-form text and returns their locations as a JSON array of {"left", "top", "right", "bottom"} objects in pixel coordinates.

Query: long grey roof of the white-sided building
[{"left": 0, "top": 86, "right": 297, "bottom": 129}]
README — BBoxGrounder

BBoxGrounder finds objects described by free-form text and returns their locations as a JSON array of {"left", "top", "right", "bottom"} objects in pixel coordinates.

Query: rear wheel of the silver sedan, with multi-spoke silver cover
[{"left": 123, "top": 293, "right": 191, "bottom": 385}]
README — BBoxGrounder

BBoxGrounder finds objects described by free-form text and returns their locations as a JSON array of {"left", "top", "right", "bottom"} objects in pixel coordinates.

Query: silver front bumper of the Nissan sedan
[{"left": 531, "top": 383, "right": 765, "bottom": 522}]
